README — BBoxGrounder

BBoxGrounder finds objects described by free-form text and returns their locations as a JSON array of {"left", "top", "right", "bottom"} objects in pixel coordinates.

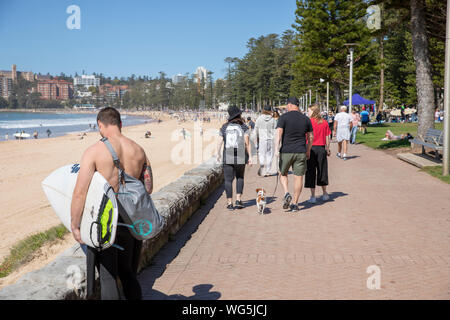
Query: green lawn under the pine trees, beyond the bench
[{"left": 356, "top": 123, "right": 443, "bottom": 149}]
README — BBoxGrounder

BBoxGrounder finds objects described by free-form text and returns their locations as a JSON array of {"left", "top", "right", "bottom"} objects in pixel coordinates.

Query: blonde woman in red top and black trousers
[{"left": 305, "top": 105, "right": 331, "bottom": 203}]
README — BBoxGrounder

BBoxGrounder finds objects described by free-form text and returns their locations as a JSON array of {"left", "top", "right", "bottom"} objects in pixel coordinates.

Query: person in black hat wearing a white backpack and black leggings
[{"left": 216, "top": 106, "right": 252, "bottom": 210}]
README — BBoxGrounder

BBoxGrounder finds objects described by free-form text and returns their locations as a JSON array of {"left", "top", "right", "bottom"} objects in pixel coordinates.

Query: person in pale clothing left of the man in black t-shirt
[{"left": 255, "top": 105, "right": 277, "bottom": 177}]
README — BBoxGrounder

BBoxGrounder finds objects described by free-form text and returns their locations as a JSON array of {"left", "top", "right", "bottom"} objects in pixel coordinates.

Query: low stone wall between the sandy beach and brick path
[{"left": 0, "top": 158, "right": 223, "bottom": 300}]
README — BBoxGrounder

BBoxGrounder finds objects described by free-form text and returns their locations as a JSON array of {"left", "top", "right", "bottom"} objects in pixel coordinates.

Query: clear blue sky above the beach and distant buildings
[{"left": 0, "top": 0, "right": 296, "bottom": 78}]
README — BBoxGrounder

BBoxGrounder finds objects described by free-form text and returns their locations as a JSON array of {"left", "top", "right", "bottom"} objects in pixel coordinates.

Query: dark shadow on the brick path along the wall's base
[{"left": 138, "top": 185, "right": 224, "bottom": 300}]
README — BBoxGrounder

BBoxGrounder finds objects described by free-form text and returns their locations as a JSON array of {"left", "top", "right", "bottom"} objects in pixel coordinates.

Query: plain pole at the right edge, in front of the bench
[{"left": 442, "top": 0, "right": 450, "bottom": 176}]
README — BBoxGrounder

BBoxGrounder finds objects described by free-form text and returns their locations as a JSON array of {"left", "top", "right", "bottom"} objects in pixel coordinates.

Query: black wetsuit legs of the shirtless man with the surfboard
[{"left": 87, "top": 217, "right": 142, "bottom": 300}]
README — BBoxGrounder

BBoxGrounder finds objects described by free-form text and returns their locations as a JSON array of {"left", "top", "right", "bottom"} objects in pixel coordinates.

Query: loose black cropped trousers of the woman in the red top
[{"left": 305, "top": 146, "right": 328, "bottom": 189}]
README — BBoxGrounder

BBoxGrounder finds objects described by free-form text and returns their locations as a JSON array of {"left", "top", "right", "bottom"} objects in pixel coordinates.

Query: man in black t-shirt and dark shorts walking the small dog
[{"left": 275, "top": 98, "right": 314, "bottom": 212}]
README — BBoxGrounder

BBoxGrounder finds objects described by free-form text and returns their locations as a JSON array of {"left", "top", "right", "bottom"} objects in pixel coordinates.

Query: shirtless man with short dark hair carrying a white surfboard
[{"left": 71, "top": 107, "right": 153, "bottom": 300}]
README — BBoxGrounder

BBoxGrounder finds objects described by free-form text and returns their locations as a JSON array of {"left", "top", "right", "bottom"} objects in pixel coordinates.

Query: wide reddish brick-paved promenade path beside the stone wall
[{"left": 140, "top": 144, "right": 450, "bottom": 299}]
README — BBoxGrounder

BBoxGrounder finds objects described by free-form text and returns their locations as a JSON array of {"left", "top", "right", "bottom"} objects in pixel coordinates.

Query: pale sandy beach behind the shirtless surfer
[{"left": 0, "top": 113, "right": 221, "bottom": 288}]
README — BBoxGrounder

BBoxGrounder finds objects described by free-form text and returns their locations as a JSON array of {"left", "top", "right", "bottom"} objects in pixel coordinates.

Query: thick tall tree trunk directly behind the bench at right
[{"left": 411, "top": 0, "right": 434, "bottom": 135}]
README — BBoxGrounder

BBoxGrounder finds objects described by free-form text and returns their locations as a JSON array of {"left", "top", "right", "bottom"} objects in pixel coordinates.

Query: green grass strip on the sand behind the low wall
[{"left": 0, "top": 224, "right": 69, "bottom": 278}]
